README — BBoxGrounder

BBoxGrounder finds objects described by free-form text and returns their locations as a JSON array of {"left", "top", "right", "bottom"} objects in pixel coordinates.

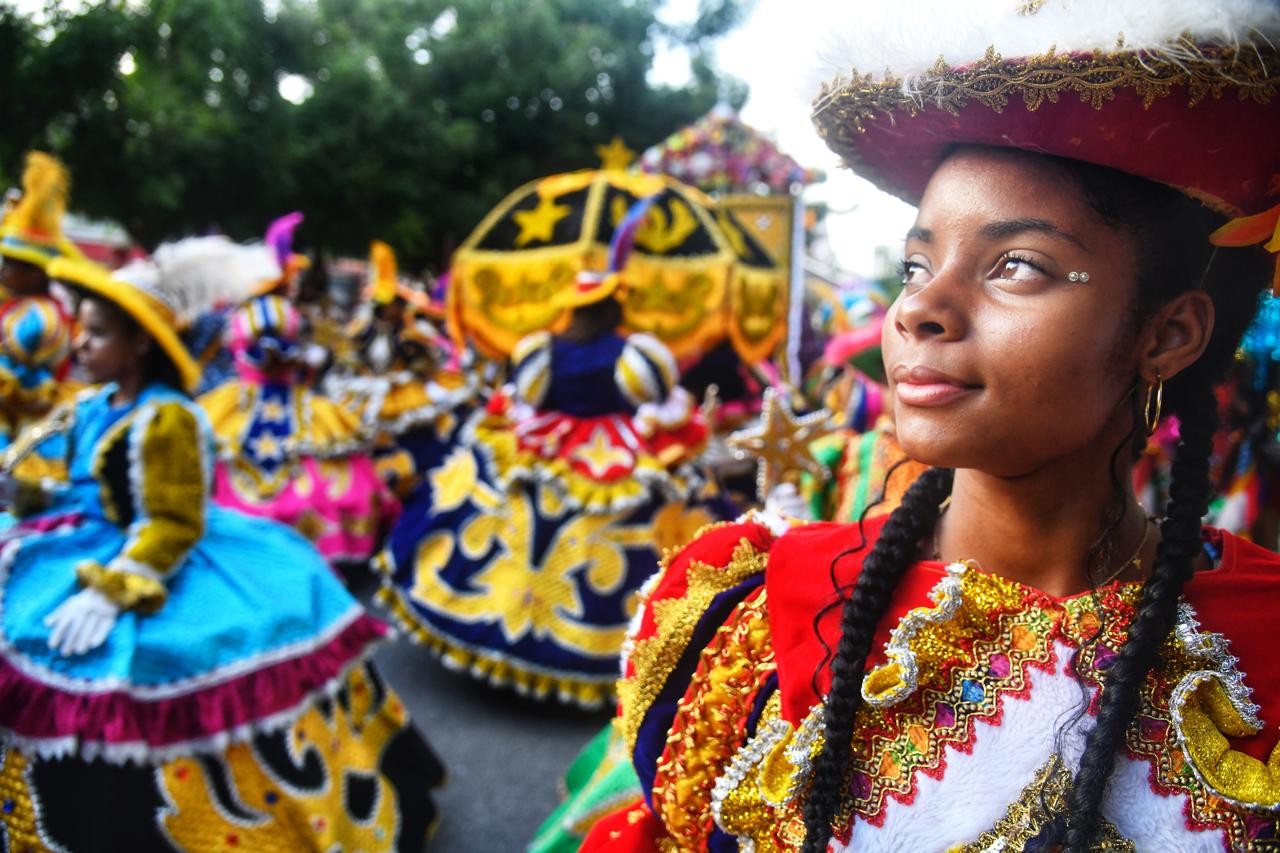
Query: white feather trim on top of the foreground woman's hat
[{"left": 810, "top": 0, "right": 1280, "bottom": 92}]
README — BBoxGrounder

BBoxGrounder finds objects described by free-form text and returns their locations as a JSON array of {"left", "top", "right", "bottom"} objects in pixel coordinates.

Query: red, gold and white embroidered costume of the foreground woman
[{"left": 582, "top": 514, "right": 1280, "bottom": 852}]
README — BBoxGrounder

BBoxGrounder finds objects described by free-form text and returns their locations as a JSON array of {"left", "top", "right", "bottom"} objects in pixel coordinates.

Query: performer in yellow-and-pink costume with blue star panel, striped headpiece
[{"left": 200, "top": 296, "right": 399, "bottom": 564}]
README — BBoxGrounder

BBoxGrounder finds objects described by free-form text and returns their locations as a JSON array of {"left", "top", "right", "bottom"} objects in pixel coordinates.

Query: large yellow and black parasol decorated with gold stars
[{"left": 449, "top": 167, "right": 786, "bottom": 357}]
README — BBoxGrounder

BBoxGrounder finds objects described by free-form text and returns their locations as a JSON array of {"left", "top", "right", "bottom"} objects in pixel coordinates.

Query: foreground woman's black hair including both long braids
[{"left": 804, "top": 149, "right": 1268, "bottom": 853}]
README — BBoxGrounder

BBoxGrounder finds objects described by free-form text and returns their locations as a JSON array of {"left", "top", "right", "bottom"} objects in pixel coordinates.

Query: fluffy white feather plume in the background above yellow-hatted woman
[{"left": 149, "top": 236, "right": 280, "bottom": 324}]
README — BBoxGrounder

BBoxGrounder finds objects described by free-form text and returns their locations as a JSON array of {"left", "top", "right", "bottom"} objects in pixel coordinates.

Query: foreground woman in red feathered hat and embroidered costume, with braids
[{"left": 585, "top": 0, "right": 1280, "bottom": 852}]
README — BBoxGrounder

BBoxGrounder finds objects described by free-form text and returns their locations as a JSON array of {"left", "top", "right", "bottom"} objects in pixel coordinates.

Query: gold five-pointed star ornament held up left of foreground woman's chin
[{"left": 728, "top": 388, "right": 837, "bottom": 503}]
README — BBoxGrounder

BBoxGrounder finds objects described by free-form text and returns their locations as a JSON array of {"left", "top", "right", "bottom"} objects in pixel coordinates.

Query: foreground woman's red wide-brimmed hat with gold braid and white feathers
[{"left": 814, "top": 0, "right": 1280, "bottom": 284}]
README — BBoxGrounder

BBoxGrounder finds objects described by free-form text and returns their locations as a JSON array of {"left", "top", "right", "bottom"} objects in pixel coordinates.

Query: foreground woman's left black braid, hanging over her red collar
[{"left": 804, "top": 467, "right": 952, "bottom": 853}]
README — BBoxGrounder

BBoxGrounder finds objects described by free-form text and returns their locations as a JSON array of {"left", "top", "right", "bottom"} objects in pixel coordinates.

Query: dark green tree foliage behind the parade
[{"left": 0, "top": 0, "right": 750, "bottom": 268}]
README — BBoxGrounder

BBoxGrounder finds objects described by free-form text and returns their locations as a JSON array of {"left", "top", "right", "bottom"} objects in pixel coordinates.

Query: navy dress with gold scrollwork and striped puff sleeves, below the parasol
[{"left": 380, "top": 334, "right": 728, "bottom": 706}]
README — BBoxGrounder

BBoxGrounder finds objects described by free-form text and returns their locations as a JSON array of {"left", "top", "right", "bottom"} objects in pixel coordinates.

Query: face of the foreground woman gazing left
[{"left": 882, "top": 147, "right": 1138, "bottom": 476}]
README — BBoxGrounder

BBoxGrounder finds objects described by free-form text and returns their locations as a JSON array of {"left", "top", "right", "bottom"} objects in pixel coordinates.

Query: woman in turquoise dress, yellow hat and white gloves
[{"left": 0, "top": 253, "right": 440, "bottom": 850}]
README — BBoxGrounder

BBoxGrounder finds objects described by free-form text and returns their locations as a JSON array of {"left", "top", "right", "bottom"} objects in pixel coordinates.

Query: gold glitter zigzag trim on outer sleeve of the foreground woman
[{"left": 618, "top": 537, "right": 768, "bottom": 751}]
